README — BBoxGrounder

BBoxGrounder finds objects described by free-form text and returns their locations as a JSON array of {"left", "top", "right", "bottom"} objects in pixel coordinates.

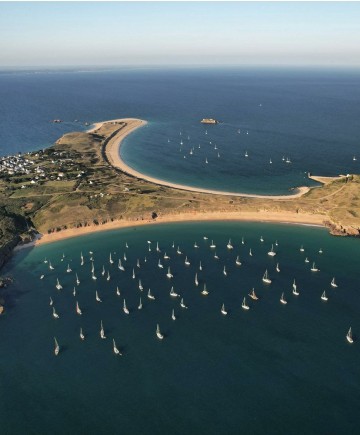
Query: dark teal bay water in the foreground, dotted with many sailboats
[{"left": 0, "top": 222, "right": 360, "bottom": 435}]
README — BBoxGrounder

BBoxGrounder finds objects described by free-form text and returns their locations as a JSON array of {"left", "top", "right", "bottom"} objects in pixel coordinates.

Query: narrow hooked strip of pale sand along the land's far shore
[{"left": 101, "top": 118, "right": 310, "bottom": 200}]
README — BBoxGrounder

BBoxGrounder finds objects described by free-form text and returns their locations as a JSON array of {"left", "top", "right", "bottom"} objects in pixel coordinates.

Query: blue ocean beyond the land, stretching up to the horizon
[{"left": 0, "top": 69, "right": 360, "bottom": 194}]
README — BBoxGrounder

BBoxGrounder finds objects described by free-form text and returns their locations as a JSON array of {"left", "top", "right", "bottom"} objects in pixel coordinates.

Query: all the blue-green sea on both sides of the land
[{"left": 0, "top": 69, "right": 360, "bottom": 435}]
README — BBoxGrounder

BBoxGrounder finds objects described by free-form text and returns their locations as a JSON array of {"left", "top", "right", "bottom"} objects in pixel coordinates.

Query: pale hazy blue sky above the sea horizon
[{"left": 0, "top": 1, "right": 360, "bottom": 68}]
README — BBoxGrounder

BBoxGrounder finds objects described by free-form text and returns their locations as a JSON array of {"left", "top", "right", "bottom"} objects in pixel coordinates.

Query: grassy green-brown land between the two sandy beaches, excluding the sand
[{"left": 0, "top": 123, "right": 360, "bottom": 272}]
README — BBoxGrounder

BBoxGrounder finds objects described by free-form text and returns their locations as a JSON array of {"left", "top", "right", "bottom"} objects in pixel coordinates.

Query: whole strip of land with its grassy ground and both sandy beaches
[{"left": 0, "top": 118, "right": 360, "bottom": 265}]
